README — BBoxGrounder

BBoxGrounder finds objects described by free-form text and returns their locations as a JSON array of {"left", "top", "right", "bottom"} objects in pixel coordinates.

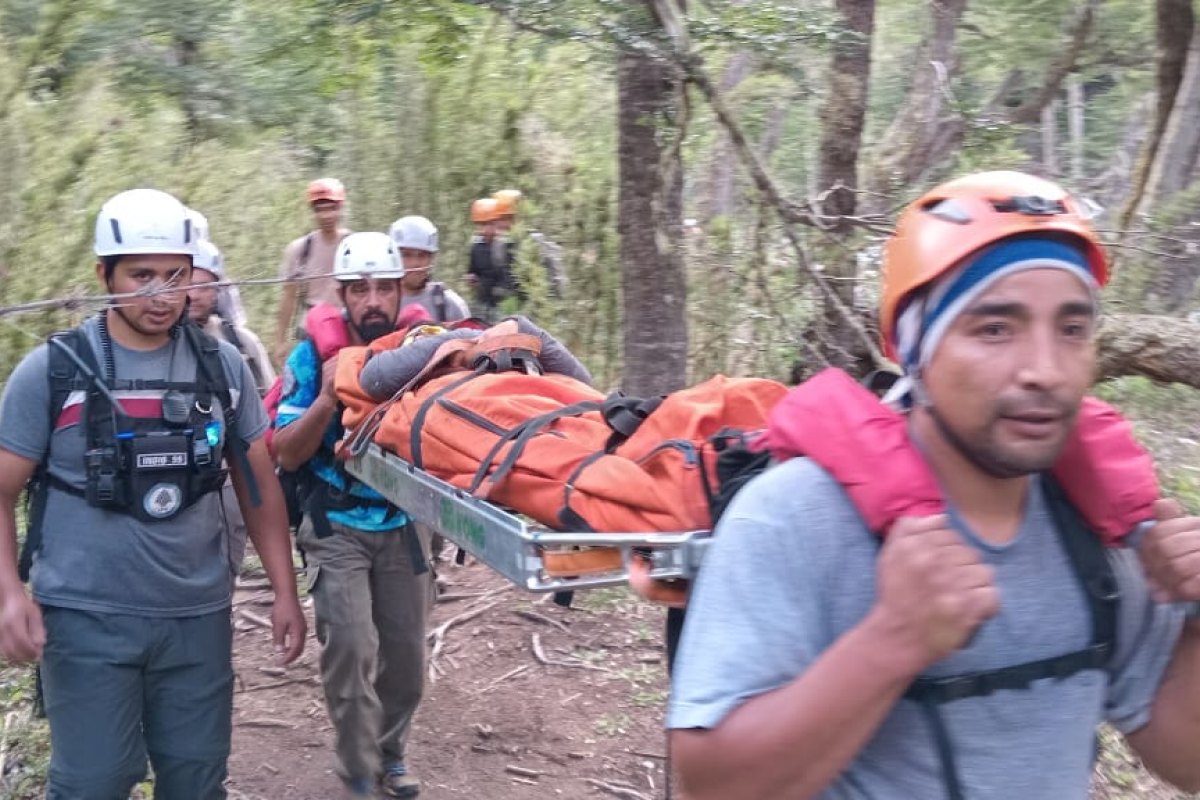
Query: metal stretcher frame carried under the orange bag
[{"left": 346, "top": 444, "right": 710, "bottom": 593}]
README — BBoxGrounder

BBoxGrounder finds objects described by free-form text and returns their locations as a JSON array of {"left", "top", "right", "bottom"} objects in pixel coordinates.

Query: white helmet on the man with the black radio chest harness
[{"left": 96, "top": 188, "right": 199, "bottom": 257}]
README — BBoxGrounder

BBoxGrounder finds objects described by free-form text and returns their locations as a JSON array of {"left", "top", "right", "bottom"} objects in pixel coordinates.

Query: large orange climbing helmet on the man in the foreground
[{"left": 880, "top": 172, "right": 1109, "bottom": 360}]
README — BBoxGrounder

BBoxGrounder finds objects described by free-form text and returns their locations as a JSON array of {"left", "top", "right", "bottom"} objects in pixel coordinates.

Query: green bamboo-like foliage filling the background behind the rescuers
[{"left": 0, "top": 0, "right": 1176, "bottom": 386}]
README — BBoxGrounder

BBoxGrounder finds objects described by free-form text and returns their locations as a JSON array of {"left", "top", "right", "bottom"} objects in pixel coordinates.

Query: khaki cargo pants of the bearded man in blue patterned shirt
[{"left": 296, "top": 516, "right": 430, "bottom": 780}]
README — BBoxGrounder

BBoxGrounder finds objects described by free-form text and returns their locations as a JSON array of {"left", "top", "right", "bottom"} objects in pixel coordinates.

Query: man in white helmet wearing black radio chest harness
[{"left": 0, "top": 190, "right": 305, "bottom": 800}]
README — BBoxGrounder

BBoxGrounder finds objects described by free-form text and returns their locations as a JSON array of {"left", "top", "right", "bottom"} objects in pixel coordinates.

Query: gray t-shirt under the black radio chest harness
[{"left": 0, "top": 318, "right": 268, "bottom": 616}]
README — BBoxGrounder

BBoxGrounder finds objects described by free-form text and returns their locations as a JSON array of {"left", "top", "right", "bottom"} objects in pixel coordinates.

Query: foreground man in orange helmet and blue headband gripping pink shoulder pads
[{"left": 667, "top": 173, "right": 1200, "bottom": 800}]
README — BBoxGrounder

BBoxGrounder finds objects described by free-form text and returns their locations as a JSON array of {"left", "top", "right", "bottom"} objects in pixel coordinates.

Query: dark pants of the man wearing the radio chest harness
[{"left": 41, "top": 607, "right": 233, "bottom": 800}]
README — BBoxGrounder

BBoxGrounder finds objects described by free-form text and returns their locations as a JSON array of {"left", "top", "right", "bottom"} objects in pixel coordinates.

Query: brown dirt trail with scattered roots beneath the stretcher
[{"left": 229, "top": 556, "right": 666, "bottom": 800}]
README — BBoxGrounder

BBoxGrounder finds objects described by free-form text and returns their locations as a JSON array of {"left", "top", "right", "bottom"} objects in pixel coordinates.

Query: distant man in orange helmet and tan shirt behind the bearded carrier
[{"left": 275, "top": 178, "right": 350, "bottom": 367}]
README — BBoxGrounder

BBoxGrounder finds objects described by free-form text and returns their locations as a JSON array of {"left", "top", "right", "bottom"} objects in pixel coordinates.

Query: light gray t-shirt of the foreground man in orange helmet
[{"left": 667, "top": 458, "right": 1183, "bottom": 800}]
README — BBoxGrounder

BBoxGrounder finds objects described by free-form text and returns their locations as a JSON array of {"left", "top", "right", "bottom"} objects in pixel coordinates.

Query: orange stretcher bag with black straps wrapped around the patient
[{"left": 337, "top": 321, "right": 787, "bottom": 542}]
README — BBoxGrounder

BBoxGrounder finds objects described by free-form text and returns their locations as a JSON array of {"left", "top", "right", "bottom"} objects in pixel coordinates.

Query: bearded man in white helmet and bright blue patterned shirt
[{"left": 275, "top": 233, "right": 430, "bottom": 798}]
